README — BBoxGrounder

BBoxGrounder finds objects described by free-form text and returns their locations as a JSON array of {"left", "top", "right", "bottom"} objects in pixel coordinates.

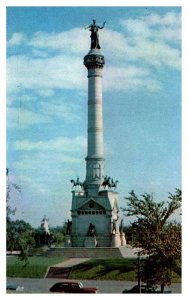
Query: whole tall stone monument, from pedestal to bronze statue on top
[{"left": 67, "top": 20, "right": 122, "bottom": 247}]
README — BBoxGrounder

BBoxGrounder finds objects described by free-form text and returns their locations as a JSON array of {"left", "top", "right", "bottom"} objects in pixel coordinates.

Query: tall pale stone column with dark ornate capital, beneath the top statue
[{"left": 84, "top": 49, "right": 105, "bottom": 190}]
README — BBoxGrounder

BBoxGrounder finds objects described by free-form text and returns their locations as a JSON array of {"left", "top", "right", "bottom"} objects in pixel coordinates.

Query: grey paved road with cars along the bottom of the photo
[{"left": 7, "top": 278, "right": 181, "bottom": 294}]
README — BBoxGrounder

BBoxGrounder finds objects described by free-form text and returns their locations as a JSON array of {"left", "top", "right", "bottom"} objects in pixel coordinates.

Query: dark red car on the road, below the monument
[{"left": 50, "top": 281, "right": 98, "bottom": 294}]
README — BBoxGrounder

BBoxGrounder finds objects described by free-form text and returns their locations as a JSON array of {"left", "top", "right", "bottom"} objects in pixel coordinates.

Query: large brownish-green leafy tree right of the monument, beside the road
[{"left": 122, "top": 189, "right": 181, "bottom": 292}]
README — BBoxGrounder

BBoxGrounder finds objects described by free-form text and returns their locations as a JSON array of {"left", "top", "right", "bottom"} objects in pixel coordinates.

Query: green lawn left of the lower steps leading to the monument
[{"left": 7, "top": 256, "right": 66, "bottom": 278}]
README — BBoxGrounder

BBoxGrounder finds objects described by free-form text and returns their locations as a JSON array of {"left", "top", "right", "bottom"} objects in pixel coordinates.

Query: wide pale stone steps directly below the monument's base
[{"left": 45, "top": 247, "right": 122, "bottom": 258}]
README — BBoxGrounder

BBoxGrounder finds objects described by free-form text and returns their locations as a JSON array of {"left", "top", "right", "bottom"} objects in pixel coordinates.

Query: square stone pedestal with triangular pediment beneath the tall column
[{"left": 71, "top": 190, "right": 121, "bottom": 247}]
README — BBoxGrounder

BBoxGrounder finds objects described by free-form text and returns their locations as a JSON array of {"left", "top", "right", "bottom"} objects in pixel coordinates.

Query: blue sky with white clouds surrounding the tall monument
[{"left": 7, "top": 7, "right": 181, "bottom": 226}]
